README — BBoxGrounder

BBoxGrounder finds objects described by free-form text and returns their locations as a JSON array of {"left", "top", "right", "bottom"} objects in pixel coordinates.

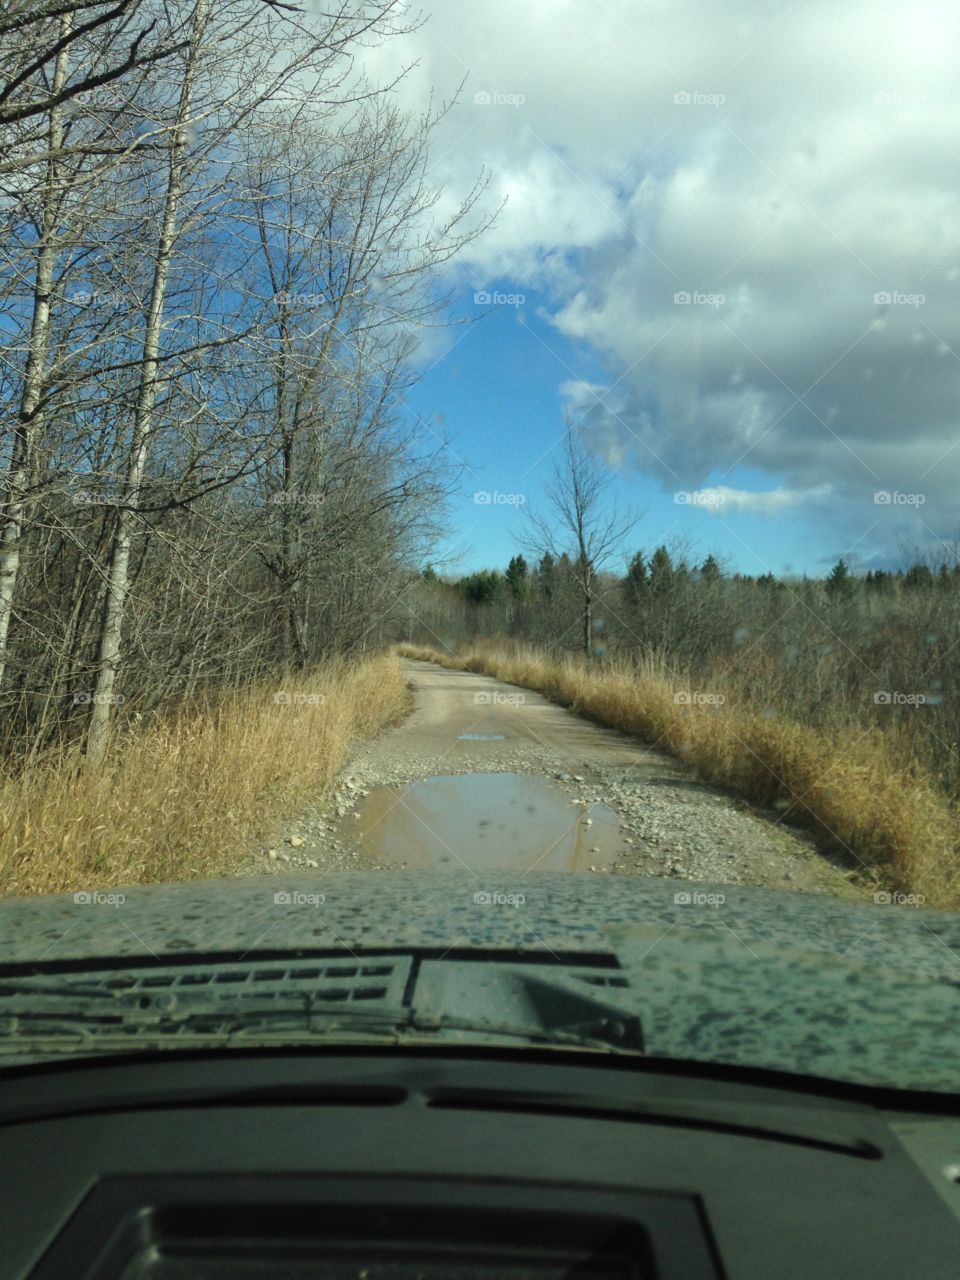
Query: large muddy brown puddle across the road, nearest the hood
[{"left": 340, "top": 773, "right": 620, "bottom": 872}]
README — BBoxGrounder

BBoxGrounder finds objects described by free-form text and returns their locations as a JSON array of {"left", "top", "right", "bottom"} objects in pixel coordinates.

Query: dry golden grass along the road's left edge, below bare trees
[{"left": 0, "top": 655, "right": 408, "bottom": 893}]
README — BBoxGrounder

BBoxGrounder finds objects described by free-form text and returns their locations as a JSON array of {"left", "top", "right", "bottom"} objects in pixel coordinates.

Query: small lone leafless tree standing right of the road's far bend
[{"left": 524, "top": 416, "right": 643, "bottom": 658}]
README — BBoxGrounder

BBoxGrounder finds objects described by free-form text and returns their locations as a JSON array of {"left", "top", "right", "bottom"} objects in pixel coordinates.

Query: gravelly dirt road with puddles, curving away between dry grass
[{"left": 248, "top": 660, "right": 867, "bottom": 897}]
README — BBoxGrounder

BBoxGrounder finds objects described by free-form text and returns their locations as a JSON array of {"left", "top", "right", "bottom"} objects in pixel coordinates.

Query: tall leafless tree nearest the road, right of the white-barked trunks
[{"left": 240, "top": 93, "right": 490, "bottom": 666}]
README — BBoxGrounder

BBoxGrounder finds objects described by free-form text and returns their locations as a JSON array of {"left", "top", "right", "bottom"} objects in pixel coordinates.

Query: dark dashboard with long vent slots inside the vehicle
[{"left": 0, "top": 1048, "right": 960, "bottom": 1280}]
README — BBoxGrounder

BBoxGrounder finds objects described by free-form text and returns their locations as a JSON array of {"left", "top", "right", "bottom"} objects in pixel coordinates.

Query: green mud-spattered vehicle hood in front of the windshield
[{"left": 0, "top": 872, "right": 960, "bottom": 1092}]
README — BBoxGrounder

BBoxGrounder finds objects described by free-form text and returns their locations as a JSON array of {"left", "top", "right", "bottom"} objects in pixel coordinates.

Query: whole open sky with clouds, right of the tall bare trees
[{"left": 365, "top": 0, "right": 960, "bottom": 575}]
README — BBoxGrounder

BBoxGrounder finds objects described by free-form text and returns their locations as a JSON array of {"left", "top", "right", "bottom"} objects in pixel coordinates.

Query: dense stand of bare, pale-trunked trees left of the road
[{"left": 0, "top": 0, "right": 496, "bottom": 765}]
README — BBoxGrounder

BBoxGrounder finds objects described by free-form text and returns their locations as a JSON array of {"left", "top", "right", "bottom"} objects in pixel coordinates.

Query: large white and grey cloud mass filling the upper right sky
[{"left": 358, "top": 0, "right": 960, "bottom": 560}]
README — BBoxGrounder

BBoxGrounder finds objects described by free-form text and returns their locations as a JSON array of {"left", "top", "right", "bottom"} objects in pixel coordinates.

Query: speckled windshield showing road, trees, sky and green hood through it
[{"left": 0, "top": 0, "right": 960, "bottom": 1092}]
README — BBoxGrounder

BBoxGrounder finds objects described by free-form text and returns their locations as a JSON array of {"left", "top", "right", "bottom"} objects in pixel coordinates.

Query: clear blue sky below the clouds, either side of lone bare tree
[{"left": 407, "top": 282, "right": 855, "bottom": 575}]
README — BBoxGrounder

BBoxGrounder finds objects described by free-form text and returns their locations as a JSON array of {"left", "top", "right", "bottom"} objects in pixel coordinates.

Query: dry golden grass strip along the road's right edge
[{"left": 399, "top": 645, "right": 960, "bottom": 909}]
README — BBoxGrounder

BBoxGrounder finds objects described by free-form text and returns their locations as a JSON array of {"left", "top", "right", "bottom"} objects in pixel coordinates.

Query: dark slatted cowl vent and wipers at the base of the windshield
[{"left": 0, "top": 952, "right": 643, "bottom": 1057}]
